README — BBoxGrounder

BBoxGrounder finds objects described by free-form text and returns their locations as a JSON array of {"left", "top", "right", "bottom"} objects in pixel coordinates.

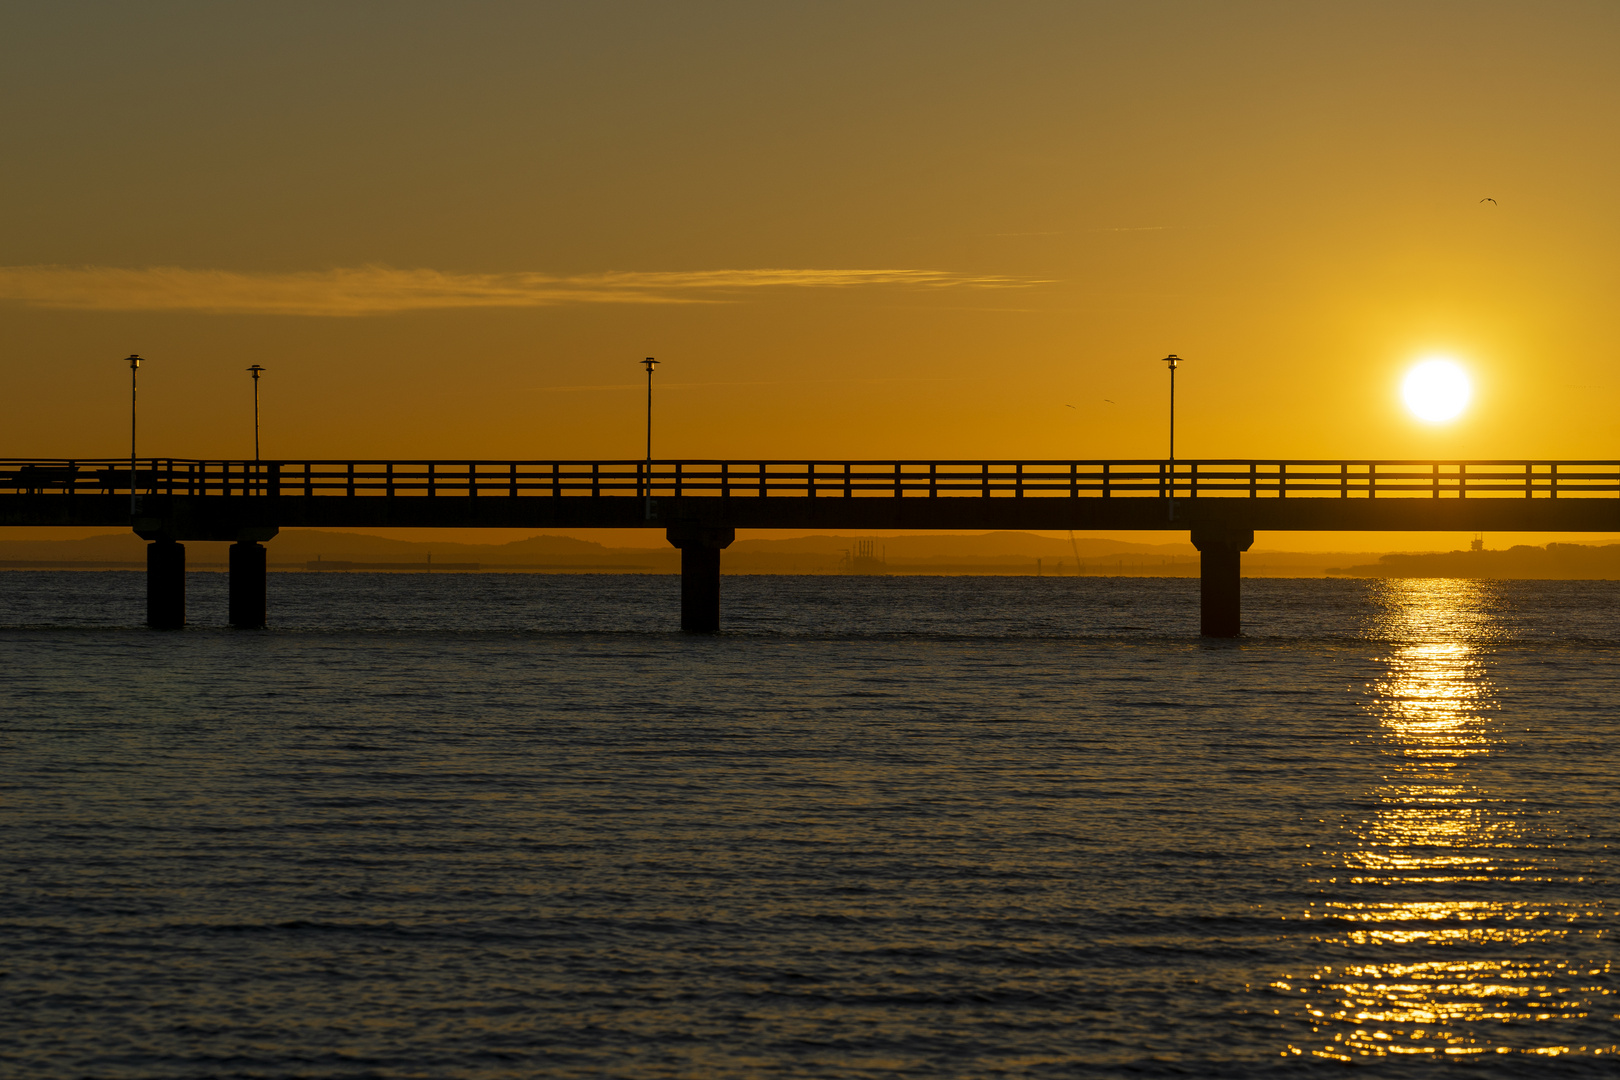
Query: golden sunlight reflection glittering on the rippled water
[{"left": 1273, "top": 580, "right": 1617, "bottom": 1062}]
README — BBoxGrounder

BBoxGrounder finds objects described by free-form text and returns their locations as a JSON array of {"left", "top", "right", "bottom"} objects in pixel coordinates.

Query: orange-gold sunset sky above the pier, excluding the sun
[{"left": 0, "top": 0, "right": 1620, "bottom": 553}]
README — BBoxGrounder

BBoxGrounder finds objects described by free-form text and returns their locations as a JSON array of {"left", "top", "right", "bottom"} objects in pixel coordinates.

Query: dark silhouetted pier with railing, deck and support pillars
[{"left": 0, "top": 458, "right": 1620, "bottom": 636}]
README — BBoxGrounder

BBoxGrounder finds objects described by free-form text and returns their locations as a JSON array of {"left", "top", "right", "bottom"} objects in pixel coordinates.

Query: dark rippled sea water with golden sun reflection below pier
[{"left": 0, "top": 573, "right": 1620, "bottom": 1078}]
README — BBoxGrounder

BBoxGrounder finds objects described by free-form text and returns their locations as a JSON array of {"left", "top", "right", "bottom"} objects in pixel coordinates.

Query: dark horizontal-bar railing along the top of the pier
[{"left": 0, "top": 458, "right": 1620, "bottom": 499}]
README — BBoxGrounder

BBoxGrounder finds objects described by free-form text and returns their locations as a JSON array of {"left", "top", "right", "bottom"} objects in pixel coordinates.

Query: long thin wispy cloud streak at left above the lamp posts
[{"left": 0, "top": 266, "right": 1037, "bottom": 316}]
